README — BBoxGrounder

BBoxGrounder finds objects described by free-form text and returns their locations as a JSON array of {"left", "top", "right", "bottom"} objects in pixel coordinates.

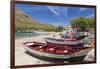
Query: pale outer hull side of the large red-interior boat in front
[{"left": 23, "top": 42, "right": 92, "bottom": 59}]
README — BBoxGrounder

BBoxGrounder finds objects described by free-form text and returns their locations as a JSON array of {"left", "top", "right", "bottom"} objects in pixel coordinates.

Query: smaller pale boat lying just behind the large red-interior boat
[{"left": 44, "top": 38, "right": 84, "bottom": 46}]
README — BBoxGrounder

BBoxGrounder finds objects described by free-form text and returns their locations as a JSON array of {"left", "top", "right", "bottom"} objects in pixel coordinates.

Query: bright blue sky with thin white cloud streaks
[{"left": 15, "top": 4, "right": 94, "bottom": 27}]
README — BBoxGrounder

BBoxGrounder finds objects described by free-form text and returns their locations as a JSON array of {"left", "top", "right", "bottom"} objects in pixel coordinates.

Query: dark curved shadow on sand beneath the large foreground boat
[{"left": 25, "top": 51, "right": 85, "bottom": 63}]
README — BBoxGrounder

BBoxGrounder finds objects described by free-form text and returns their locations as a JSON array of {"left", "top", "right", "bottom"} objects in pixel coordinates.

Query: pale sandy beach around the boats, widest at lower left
[{"left": 15, "top": 33, "right": 94, "bottom": 65}]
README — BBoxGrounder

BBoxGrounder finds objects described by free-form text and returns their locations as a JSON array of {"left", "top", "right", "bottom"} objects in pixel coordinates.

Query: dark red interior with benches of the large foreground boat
[{"left": 24, "top": 42, "right": 89, "bottom": 55}]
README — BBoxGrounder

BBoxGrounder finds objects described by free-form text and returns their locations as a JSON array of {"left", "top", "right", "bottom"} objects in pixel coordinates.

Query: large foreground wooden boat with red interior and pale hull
[{"left": 23, "top": 42, "right": 92, "bottom": 59}]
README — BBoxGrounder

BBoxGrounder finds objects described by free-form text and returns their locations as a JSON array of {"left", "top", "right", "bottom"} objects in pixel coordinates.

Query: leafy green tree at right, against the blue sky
[{"left": 70, "top": 17, "right": 94, "bottom": 31}]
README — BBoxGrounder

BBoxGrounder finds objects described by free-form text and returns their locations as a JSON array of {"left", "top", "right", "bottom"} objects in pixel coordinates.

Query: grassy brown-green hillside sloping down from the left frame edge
[{"left": 15, "top": 9, "right": 58, "bottom": 32}]
